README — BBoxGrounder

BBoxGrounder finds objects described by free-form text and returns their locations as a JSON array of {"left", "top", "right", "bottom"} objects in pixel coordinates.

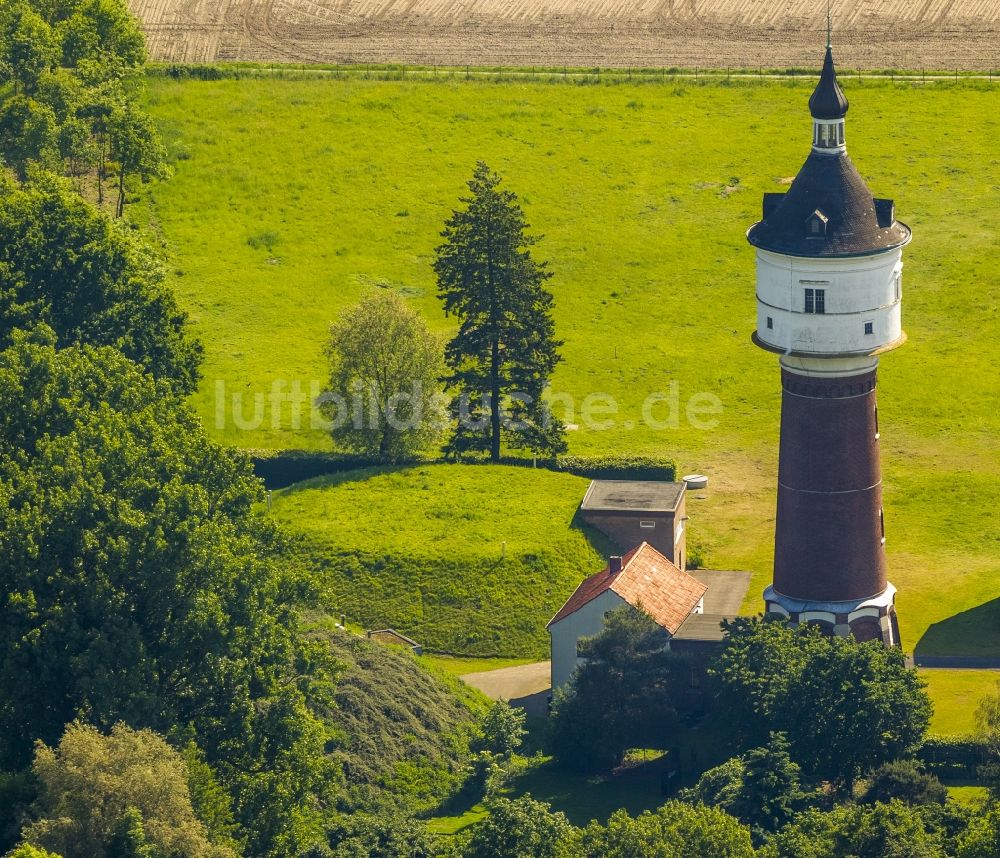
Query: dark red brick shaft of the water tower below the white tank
[{"left": 774, "top": 368, "right": 886, "bottom": 602}]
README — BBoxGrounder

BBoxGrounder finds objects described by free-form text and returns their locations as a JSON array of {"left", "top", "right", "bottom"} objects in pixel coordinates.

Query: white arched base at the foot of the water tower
[{"left": 764, "top": 584, "right": 900, "bottom": 646}]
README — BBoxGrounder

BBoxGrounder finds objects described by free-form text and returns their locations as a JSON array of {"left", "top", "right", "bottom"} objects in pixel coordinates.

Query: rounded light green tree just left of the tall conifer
[{"left": 322, "top": 290, "right": 444, "bottom": 462}]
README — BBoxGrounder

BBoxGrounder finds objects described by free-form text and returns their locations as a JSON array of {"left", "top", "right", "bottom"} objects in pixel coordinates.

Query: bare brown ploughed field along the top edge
[{"left": 130, "top": 0, "right": 1000, "bottom": 70}]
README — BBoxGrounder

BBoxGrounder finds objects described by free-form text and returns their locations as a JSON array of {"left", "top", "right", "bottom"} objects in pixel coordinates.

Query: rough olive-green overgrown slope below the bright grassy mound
[{"left": 308, "top": 617, "right": 488, "bottom": 811}]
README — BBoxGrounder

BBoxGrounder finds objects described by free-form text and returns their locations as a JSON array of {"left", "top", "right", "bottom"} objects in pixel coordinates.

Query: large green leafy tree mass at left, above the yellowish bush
[{"left": 0, "top": 331, "right": 336, "bottom": 855}]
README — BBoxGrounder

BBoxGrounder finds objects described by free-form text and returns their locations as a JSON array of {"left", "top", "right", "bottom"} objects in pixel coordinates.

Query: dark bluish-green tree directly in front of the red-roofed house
[{"left": 549, "top": 607, "right": 691, "bottom": 771}]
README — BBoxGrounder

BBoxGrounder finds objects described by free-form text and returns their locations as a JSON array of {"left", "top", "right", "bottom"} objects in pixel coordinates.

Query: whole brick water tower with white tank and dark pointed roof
[{"left": 747, "top": 39, "right": 910, "bottom": 645}]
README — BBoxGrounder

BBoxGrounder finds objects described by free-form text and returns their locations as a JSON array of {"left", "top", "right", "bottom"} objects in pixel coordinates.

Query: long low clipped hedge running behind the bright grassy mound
[{"left": 246, "top": 450, "right": 677, "bottom": 489}]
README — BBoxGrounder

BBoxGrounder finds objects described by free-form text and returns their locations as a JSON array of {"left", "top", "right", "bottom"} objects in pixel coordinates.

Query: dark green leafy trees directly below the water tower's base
[{"left": 713, "top": 618, "right": 931, "bottom": 785}]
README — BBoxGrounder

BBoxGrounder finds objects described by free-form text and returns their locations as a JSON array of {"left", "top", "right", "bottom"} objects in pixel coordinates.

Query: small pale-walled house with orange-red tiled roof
[{"left": 548, "top": 542, "right": 708, "bottom": 689}]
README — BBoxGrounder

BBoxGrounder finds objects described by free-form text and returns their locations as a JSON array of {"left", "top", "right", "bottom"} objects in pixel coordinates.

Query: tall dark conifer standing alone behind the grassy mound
[{"left": 434, "top": 161, "right": 566, "bottom": 461}]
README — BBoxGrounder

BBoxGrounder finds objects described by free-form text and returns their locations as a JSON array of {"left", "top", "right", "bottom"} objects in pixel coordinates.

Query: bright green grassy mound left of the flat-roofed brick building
[{"left": 273, "top": 465, "right": 602, "bottom": 657}]
